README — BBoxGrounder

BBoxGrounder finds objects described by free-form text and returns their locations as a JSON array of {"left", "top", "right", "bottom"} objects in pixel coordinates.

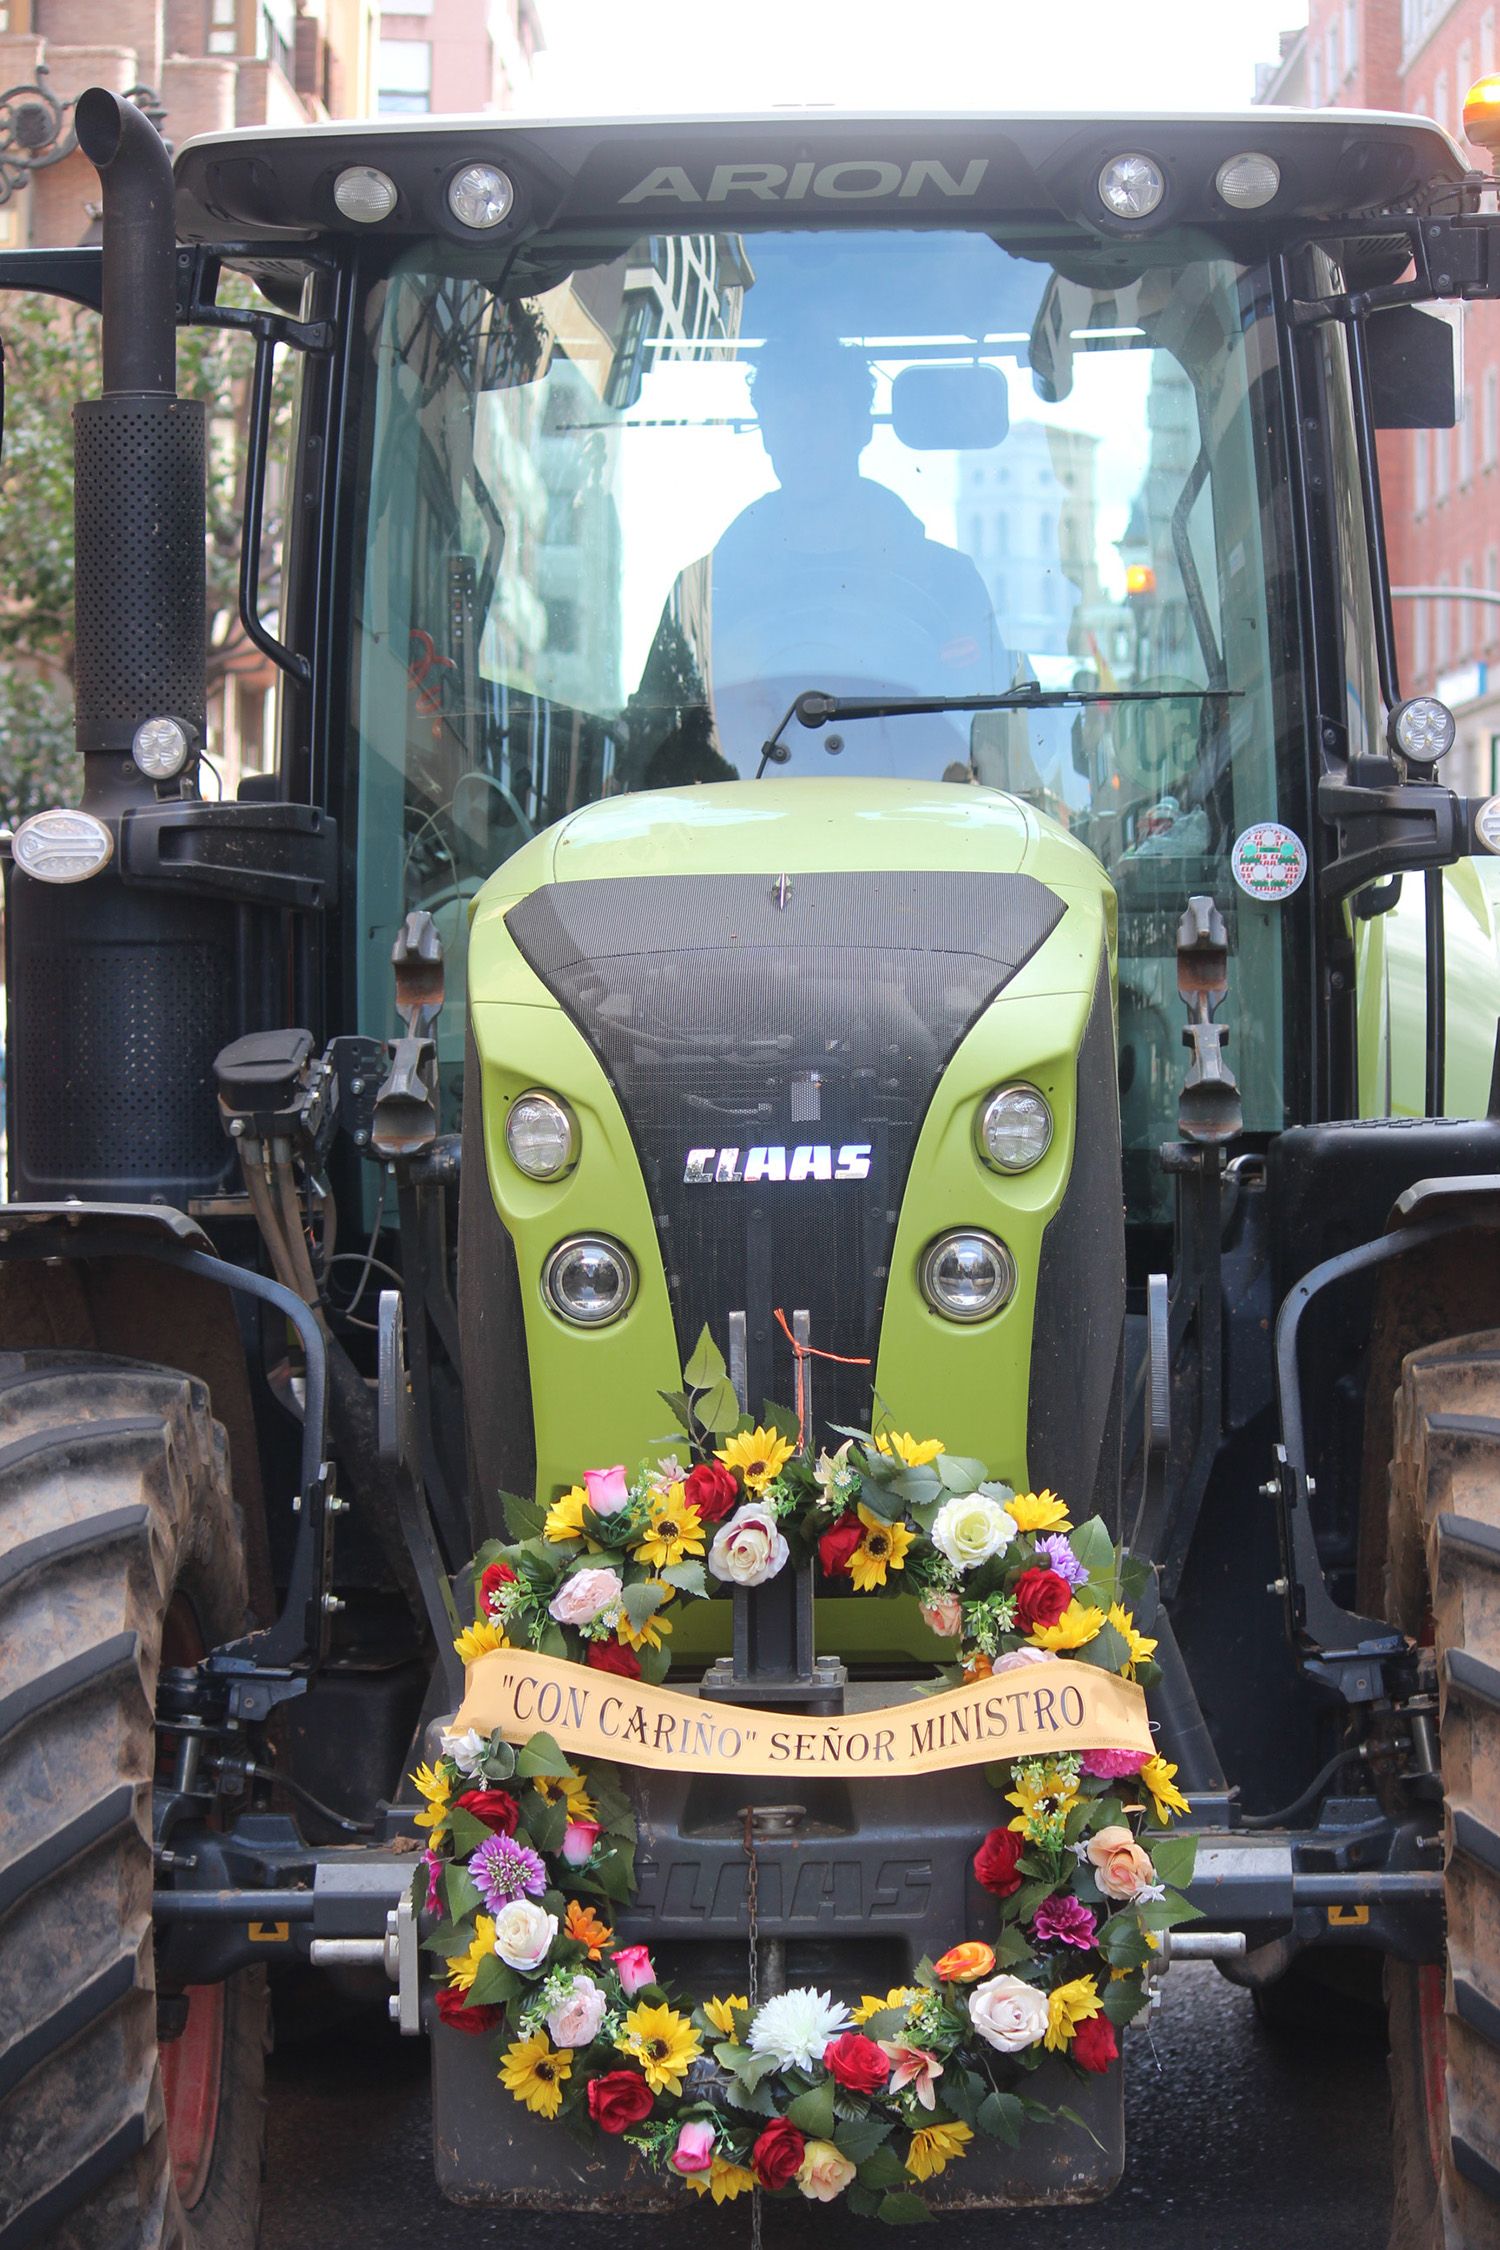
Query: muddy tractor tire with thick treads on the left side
[{"left": 0, "top": 1352, "right": 268, "bottom": 2250}]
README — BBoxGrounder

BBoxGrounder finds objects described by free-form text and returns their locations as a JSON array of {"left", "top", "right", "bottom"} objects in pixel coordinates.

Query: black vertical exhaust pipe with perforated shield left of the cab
[{"left": 74, "top": 86, "right": 207, "bottom": 819}]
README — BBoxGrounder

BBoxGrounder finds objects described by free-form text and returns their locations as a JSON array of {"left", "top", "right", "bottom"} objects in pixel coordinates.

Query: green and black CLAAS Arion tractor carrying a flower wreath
[{"left": 0, "top": 90, "right": 1500, "bottom": 2250}]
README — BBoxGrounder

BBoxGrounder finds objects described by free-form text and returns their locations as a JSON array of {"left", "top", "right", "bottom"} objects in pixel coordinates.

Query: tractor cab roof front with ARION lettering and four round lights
[{"left": 178, "top": 108, "right": 1475, "bottom": 248}]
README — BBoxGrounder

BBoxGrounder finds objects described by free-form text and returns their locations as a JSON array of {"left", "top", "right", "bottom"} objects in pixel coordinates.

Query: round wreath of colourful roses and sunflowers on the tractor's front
[{"left": 414, "top": 1332, "right": 1196, "bottom": 2221}]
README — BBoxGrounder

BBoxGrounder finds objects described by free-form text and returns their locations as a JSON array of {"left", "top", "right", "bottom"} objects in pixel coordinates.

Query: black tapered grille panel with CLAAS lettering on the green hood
[{"left": 506, "top": 873, "right": 1064, "bottom": 1427}]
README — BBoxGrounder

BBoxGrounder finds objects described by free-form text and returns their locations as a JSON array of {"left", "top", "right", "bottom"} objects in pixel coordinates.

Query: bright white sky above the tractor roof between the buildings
[{"left": 528, "top": 0, "right": 1307, "bottom": 117}]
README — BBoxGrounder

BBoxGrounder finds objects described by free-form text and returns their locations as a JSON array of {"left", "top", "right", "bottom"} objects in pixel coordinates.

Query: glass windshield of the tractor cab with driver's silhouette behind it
[{"left": 353, "top": 230, "right": 1295, "bottom": 1208}]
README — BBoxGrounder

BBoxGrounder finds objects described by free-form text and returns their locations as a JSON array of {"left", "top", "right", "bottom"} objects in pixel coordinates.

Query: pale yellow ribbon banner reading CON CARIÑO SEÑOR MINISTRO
[{"left": 454, "top": 1649, "right": 1151, "bottom": 1780}]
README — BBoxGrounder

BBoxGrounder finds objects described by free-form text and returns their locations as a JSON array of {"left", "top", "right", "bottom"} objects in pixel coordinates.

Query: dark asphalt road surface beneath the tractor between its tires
[{"left": 263, "top": 1964, "right": 1390, "bottom": 2250}]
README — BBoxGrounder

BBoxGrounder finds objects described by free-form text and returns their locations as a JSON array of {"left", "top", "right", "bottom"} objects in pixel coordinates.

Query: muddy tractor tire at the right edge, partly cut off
[{"left": 1385, "top": 1332, "right": 1500, "bottom": 2250}]
